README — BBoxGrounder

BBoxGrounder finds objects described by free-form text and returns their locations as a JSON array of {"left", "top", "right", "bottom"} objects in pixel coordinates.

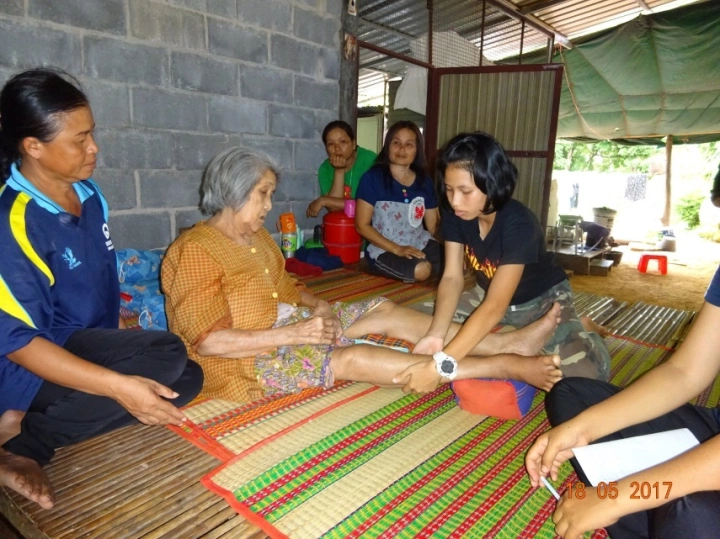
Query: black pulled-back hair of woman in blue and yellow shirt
[{"left": 0, "top": 68, "right": 89, "bottom": 183}]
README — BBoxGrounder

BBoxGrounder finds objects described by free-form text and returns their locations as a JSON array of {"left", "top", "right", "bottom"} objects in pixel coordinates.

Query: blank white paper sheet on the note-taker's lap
[{"left": 573, "top": 429, "right": 699, "bottom": 486}]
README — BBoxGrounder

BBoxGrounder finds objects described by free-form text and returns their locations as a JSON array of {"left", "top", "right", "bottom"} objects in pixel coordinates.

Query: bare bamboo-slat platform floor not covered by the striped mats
[{"left": 0, "top": 293, "right": 695, "bottom": 539}]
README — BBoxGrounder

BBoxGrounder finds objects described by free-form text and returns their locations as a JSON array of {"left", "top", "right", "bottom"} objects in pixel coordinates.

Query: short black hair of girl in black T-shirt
[{"left": 437, "top": 131, "right": 518, "bottom": 215}]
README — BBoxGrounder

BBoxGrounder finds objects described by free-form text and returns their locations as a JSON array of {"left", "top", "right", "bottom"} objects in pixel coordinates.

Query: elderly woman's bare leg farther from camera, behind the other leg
[{"left": 345, "top": 301, "right": 560, "bottom": 356}]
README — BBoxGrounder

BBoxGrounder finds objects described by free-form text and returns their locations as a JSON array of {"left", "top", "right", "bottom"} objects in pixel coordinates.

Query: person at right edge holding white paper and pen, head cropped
[{"left": 525, "top": 268, "right": 720, "bottom": 539}]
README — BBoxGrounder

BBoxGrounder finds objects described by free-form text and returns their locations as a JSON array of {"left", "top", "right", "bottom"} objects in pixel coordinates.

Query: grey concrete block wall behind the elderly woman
[{"left": 0, "top": 0, "right": 345, "bottom": 249}]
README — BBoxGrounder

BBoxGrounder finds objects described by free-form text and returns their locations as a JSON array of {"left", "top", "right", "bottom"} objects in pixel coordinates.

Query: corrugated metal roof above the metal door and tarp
[{"left": 358, "top": 0, "right": 703, "bottom": 106}]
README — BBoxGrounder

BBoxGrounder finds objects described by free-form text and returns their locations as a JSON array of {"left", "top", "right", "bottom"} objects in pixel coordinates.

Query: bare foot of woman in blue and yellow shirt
[{"left": 0, "top": 449, "right": 55, "bottom": 509}]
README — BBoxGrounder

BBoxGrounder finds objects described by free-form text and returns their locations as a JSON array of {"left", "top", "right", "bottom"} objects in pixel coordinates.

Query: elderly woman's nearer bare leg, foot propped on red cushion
[{"left": 330, "top": 345, "right": 562, "bottom": 391}]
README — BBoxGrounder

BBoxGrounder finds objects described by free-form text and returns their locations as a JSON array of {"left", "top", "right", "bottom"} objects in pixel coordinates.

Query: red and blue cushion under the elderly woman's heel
[{"left": 451, "top": 378, "right": 535, "bottom": 419}]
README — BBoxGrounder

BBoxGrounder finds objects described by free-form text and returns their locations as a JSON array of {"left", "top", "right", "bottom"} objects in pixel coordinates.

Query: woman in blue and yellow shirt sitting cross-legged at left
[{"left": 0, "top": 69, "right": 202, "bottom": 508}]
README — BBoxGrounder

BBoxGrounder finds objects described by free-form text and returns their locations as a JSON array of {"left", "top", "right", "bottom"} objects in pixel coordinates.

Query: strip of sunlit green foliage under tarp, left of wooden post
[{"left": 553, "top": 140, "right": 658, "bottom": 172}]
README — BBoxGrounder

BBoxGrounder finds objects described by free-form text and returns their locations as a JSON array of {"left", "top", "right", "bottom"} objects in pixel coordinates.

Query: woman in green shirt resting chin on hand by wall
[{"left": 306, "top": 120, "right": 376, "bottom": 217}]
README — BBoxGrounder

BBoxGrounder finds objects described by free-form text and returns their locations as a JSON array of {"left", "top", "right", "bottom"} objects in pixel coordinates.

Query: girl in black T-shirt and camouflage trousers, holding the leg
[{"left": 399, "top": 133, "right": 610, "bottom": 391}]
